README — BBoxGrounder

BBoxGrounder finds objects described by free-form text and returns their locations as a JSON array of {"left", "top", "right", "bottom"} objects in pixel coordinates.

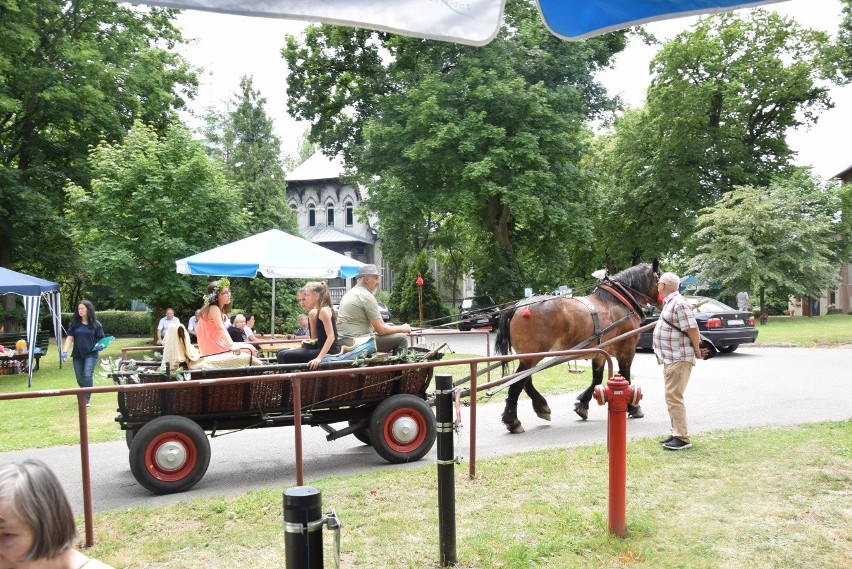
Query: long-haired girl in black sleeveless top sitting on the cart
[{"left": 276, "top": 282, "right": 340, "bottom": 369}]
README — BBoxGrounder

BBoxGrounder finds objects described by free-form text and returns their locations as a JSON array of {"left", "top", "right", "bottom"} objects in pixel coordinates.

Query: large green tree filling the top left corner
[{"left": 0, "top": 0, "right": 197, "bottom": 275}]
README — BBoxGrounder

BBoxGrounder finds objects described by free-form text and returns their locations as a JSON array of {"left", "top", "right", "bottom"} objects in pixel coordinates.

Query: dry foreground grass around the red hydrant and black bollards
[{"left": 80, "top": 421, "right": 852, "bottom": 569}]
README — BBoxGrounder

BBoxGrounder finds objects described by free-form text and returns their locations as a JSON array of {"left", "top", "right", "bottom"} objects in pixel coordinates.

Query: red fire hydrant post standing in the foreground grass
[{"left": 595, "top": 375, "right": 642, "bottom": 537}]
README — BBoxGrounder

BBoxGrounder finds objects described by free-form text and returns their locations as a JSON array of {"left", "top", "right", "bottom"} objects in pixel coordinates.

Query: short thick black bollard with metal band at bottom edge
[{"left": 284, "top": 486, "right": 324, "bottom": 569}]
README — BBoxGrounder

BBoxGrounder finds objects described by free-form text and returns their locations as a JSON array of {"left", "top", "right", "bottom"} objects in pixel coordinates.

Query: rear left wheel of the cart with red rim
[{"left": 130, "top": 415, "right": 210, "bottom": 494}]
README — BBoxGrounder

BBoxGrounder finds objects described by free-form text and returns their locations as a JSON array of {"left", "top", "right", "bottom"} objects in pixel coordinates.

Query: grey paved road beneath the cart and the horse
[{"left": 0, "top": 335, "right": 852, "bottom": 513}]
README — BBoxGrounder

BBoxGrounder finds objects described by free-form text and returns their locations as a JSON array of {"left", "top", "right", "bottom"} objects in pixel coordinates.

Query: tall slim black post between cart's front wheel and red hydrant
[{"left": 435, "top": 375, "right": 458, "bottom": 567}]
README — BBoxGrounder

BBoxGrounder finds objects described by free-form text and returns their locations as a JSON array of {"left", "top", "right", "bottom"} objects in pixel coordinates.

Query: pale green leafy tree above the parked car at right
[{"left": 689, "top": 170, "right": 852, "bottom": 306}]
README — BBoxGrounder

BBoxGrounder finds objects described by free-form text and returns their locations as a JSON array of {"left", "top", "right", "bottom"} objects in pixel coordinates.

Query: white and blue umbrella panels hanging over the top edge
[{"left": 134, "top": 0, "right": 784, "bottom": 45}]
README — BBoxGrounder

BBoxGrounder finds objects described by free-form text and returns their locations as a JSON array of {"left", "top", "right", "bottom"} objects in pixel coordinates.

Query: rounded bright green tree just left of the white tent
[{"left": 65, "top": 121, "right": 244, "bottom": 314}]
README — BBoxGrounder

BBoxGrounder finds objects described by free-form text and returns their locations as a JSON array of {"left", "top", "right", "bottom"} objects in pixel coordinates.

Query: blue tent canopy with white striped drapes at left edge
[{"left": 0, "top": 267, "right": 62, "bottom": 387}]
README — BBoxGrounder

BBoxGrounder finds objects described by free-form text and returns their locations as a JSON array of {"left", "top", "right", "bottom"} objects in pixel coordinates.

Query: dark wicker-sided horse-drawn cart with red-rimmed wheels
[{"left": 111, "top": 344, "right": 442, "bottom": 494}]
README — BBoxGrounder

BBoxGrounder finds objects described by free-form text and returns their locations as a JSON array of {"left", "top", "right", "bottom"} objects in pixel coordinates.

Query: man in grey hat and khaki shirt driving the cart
[{"left": 337, "top": 265, "right": 411, "bottom": 353}]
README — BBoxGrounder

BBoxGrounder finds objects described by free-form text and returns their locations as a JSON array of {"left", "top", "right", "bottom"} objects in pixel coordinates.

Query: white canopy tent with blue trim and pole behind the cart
[{"left": 175, "top": 229, "right": 363, "bottom": 331}]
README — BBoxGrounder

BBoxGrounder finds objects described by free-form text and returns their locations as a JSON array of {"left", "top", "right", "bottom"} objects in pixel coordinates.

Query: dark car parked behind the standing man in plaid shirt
[{"left": 636, "top": 296, "right": 757, "bottom": 354}]
